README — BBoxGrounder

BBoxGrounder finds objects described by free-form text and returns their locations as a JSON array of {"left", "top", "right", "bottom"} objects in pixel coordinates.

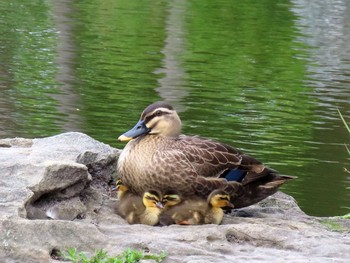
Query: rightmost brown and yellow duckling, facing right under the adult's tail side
[{"left": 159, "top": 189, "right": 234, "bottom": 225}]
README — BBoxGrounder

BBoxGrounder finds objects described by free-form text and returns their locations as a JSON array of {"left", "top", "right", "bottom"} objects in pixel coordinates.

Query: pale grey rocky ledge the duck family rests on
[{"left": 0, "top": 132, "right": 350, "bottom": 263}]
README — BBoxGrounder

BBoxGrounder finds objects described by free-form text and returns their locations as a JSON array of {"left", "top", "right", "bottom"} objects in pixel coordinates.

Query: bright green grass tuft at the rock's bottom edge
[{"left": 60, "top": 248, "right": 166, "bottom": 263}]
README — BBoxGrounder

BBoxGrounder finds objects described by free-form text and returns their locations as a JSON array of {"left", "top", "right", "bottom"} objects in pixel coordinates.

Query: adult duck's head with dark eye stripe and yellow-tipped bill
[{"left": 118, "top": 101, "right": 181, "bottom": 141}]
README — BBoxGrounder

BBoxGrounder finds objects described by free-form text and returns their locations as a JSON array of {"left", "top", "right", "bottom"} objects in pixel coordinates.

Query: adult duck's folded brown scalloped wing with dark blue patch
[{"left": 159, "top": 136, "right": 294, "bottom": 187}]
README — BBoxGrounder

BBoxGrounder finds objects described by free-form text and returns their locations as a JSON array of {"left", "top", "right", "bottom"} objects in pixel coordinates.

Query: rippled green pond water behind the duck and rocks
[{"left": 0, "top": 0, "right": 350, "bottom": 216}]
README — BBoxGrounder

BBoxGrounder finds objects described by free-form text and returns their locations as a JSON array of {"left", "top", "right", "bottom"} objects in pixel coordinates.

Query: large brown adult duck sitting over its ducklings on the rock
[{"left": 117, "top": 101, "right": 295, "bottom": 208}]
